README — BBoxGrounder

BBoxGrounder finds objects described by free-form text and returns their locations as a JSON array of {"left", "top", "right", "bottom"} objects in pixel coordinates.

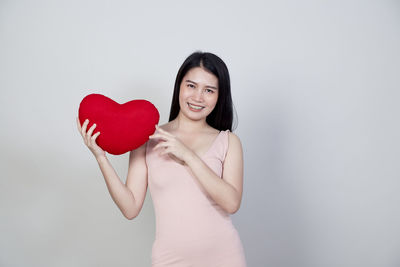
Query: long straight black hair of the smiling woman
[{"left": 168, "top": 51, "right": 237, "bottom": 132}]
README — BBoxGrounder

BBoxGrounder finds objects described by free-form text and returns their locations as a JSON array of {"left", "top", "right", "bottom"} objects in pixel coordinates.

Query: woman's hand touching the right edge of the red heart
[{"left": 149, "top": 125, "right": 193, "bottom": 164}]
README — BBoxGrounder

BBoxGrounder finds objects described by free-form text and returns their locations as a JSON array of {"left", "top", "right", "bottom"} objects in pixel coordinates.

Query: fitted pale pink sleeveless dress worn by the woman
[{"left": 146, "top": 130, "right": 246, "bottom": 267}]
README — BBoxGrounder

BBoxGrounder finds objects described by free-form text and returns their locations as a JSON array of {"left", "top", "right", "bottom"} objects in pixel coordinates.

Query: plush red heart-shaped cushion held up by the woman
[{"left": 79, "top": 94, "right": 160, "bottom": 155}]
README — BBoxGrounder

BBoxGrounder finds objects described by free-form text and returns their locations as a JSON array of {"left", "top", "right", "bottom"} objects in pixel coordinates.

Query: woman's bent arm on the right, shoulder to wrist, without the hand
[{"left": 186, "top": 132, "right": 243, "bottom": 214}]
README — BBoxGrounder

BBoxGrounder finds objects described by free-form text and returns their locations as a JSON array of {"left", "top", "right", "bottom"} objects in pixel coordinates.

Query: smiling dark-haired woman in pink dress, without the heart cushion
[{"left": 77, "top": 52, "right": 246, "bottom": 267}]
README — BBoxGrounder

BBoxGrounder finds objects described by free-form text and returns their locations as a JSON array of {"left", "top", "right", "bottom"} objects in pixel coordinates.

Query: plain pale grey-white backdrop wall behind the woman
[{"left": 0, "top": 0, "right": 400, "bottom": 267}]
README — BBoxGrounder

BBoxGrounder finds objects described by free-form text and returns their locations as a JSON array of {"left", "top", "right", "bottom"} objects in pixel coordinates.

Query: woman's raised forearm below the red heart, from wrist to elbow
[{"left": 96, "top": 157, "right": 137, "bottom": 220}]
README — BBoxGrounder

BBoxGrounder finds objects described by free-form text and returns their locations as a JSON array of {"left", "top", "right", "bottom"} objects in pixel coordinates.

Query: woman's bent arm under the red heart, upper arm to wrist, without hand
[{"left": 96, "top": 143, "right": 147, "bottom": 220}]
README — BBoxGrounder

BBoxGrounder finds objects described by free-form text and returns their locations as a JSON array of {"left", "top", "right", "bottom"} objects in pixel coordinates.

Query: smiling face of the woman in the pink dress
[{"left": 179, "top": 67, "right": 219, "bottom": 119}]
